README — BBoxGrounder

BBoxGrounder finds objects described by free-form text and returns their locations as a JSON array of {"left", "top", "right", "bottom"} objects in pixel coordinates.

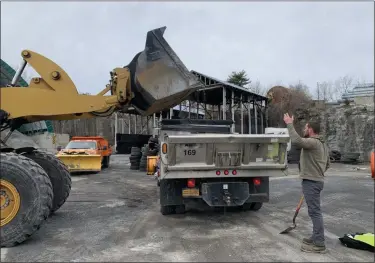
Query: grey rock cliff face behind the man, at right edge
[{"left": 322, "top": 105, "right": 374, "bottom": 162}]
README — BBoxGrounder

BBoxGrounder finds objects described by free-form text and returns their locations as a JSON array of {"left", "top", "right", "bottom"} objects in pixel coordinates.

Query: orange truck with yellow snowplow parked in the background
[{"left": 56, "top": 136, "right": 112, "bottom": 173}]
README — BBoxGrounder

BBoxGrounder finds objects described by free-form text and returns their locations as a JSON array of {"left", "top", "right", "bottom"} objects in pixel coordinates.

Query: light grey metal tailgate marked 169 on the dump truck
[{"left": 161, "top": 134, "right": 290, "bottom": 171}]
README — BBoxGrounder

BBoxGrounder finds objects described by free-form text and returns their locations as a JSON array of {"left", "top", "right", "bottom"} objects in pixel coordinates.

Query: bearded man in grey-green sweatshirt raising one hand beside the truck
[{"left": 284, "top": 113, "right": 330, "bottom": 253}]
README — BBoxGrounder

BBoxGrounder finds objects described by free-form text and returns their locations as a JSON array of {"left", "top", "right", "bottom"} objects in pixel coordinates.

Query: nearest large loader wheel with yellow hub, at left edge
[{"left": 0, "top": 153, "right": 53, "bottom": 247}]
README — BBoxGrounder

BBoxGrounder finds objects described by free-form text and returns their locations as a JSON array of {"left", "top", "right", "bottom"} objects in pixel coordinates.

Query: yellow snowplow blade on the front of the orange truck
[{"left": 56, "top": 154, "right": 102, "bottom": 173}]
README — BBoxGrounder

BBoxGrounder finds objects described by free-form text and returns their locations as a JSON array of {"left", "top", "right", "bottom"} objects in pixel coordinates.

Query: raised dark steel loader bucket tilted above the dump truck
[{"left": 125, "top": 27, "right": 202, "bottom": 115}]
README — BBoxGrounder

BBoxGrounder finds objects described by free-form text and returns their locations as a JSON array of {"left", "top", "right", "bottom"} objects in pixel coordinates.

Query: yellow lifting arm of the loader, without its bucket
[{"left": 0, "top": 50, "right": 131, "bottom": 125}]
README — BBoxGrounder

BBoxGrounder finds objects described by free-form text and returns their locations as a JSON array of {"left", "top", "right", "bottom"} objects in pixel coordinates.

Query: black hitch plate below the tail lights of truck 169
[{"left": 202, "top": 182, "right": 250, "bottom": 206}]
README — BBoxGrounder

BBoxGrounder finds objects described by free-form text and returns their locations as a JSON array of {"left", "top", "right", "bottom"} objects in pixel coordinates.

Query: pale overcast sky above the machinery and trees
[{"left": 1, "top": 2, "right": 374, "bottom": 96}]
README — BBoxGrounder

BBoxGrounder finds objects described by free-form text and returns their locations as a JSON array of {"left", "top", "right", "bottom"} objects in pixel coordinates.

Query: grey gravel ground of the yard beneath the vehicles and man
[{"left": 1, "top": 155, "right": 374, "bottom": 262}]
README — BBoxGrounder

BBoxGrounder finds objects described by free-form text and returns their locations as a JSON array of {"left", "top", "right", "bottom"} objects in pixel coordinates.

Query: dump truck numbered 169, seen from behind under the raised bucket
[{"left": 157, "top": 119, "right": 290, "bottom": 215}]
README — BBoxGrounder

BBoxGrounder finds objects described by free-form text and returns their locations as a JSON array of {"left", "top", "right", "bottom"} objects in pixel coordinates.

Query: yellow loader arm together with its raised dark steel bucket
[{"left": 0, "top": 27, "right": 202, "bottom": 133}]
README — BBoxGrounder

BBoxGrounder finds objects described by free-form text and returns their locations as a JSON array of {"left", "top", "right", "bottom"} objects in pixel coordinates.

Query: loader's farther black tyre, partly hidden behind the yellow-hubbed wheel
[{"left": 23, "top": 150, "right": 72, "bottom": 214}]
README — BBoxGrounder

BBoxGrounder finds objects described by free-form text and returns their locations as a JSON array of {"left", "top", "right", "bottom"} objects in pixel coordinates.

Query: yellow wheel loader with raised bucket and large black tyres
[{"left": 0, "top": 27, "right": 201, "bottom": 247}]
